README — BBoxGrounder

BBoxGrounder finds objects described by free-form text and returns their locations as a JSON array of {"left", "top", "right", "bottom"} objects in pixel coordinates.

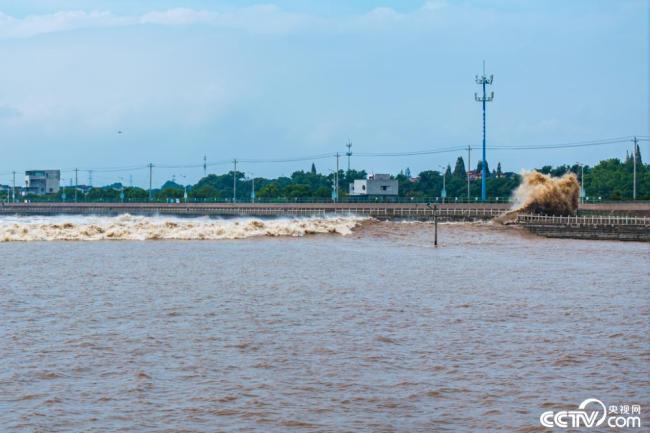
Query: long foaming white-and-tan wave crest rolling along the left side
[{"left": 0, "top": 214, "right": 367, "bottom": 242}]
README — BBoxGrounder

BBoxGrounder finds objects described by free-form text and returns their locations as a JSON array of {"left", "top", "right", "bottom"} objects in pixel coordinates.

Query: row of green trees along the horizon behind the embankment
[{"left": 0, "top": 148, "right": 650, "bottom": 202}]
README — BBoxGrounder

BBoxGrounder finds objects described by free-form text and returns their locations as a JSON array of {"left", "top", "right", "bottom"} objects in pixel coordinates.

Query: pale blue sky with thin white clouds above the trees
[{"left": 0, "top": 0, "right": 650, "bottom": 185}]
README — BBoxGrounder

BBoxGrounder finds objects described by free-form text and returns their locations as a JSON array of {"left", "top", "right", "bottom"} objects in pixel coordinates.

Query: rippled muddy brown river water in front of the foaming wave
[{"left": 0, "top": 218, "right": 650, "bottom": 432}]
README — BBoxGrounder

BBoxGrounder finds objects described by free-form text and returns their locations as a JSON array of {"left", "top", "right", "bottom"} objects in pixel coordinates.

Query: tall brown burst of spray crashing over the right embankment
[{"left": 496, "top": 171, "right": 580, "bottom": 223}]
